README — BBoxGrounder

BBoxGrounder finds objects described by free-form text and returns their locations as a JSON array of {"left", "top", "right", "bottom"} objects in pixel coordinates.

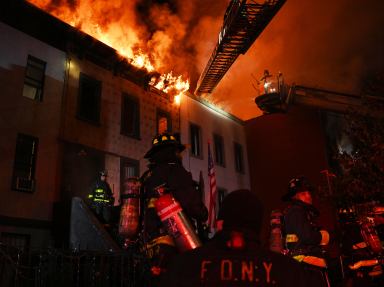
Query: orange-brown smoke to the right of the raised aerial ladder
[{"left": 212, "top": 0, "right": 384, "bottom": 119}]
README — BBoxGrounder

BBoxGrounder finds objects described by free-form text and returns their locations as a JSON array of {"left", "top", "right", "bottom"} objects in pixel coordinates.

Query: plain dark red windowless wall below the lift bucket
[{"left": 246, "top": 106, "right": 334, "bottom": 241}]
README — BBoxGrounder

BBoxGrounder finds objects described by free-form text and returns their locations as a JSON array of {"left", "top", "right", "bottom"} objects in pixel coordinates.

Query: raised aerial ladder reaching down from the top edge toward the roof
[{"left": 195, "top": 0, "right": 286, "bottom": 95}]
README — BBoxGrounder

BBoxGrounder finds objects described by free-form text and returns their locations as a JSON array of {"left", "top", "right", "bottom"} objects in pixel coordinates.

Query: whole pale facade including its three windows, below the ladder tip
[{"left": 180, "top": 94, "right": 250, "bottom": 214}]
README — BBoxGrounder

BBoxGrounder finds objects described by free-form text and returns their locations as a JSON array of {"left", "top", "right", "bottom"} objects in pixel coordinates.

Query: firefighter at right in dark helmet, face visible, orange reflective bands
[{"left": 282, "top": 176, "right": 329, "bottom": 286}]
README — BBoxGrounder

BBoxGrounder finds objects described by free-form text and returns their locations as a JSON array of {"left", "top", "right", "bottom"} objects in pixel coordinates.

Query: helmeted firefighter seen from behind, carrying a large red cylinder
[{"left": 141, "top": 133, "right": 208, "bottom": 286}]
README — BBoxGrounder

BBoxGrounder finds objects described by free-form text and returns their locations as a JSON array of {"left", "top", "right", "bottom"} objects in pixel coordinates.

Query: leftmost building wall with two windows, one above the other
[{"left": 0, "top": 22, "right": 66, "bottom": 246}]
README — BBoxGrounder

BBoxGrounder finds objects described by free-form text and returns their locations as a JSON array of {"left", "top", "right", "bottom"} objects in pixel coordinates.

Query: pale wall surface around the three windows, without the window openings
[{"left": 180, "top": 96, "right": 250, "bottom": 209}]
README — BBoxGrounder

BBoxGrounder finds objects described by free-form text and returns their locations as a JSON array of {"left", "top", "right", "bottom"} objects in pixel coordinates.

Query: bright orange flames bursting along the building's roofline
[{"left": 27, "top": 0, "right": 189, "bottom": 97}]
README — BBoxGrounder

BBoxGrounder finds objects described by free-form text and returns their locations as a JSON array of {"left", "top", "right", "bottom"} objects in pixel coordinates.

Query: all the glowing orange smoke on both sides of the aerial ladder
[{"left": 29, "top": 0, "right": 384, "bottom": 120}]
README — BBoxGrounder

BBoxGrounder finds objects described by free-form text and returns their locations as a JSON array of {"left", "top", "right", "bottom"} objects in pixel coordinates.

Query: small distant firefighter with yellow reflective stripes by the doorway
[{"left": 88, "top": 170, "right": 115, "bottom": 225}]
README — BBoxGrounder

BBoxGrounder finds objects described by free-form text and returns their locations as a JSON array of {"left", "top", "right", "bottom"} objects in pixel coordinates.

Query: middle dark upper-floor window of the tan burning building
[{"left": 120, "top": 94, "right": 140, "bottom": 138}]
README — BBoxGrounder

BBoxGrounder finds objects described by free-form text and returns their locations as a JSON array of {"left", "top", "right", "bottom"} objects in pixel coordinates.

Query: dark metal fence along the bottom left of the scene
[{"left": 0, "top": 243, "right": 149, "bottom": 287}]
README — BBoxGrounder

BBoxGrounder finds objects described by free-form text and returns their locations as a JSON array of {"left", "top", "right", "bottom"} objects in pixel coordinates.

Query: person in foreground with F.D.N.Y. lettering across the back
[{"left": 160, "top": 190, "right": 318, "bottom": 287}]
